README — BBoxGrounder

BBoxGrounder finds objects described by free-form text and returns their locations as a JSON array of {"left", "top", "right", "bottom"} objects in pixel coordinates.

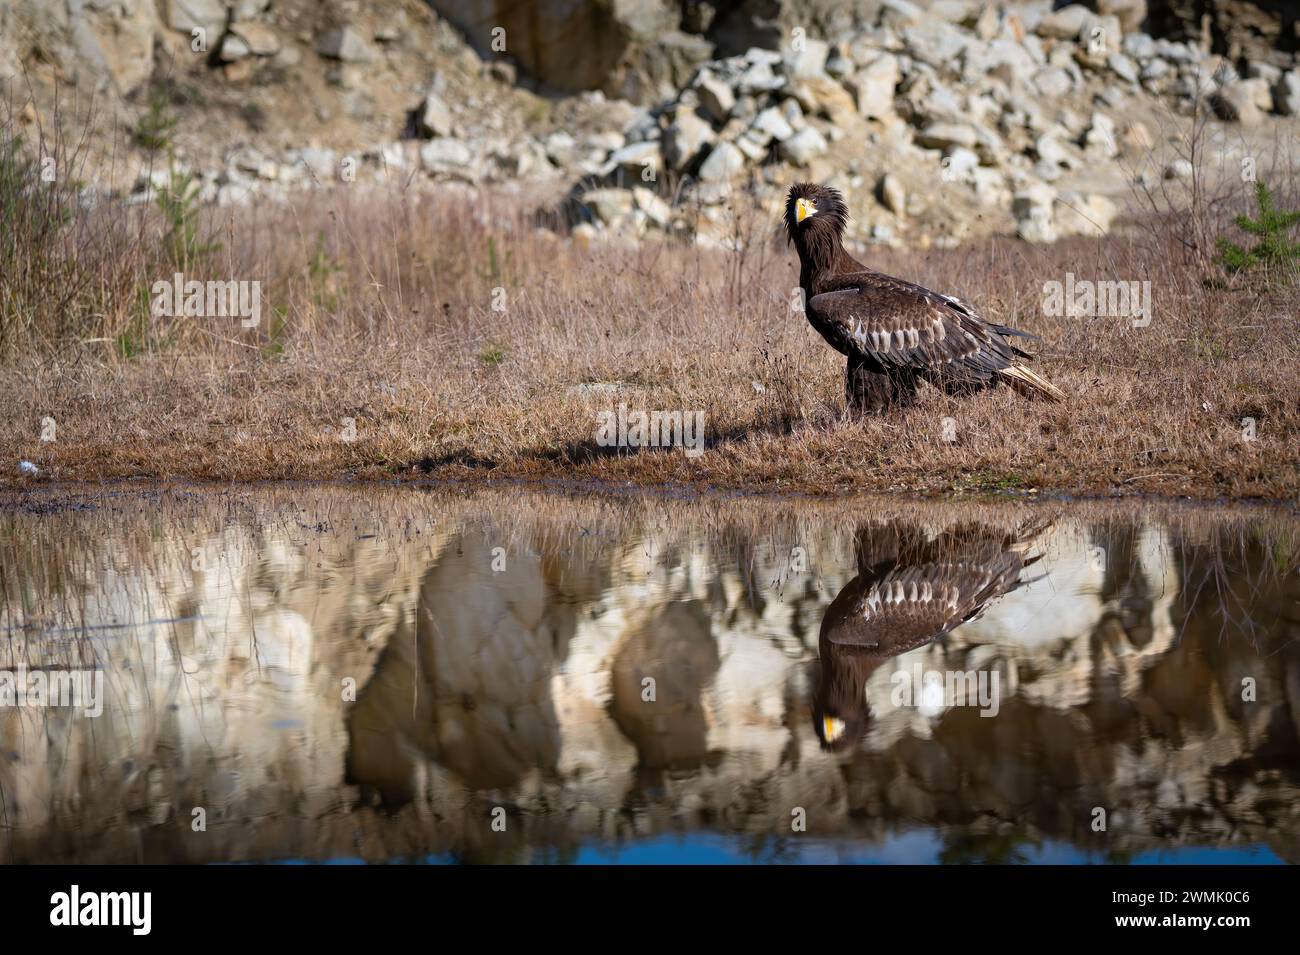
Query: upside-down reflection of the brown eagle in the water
[{"left": 813, "top": 522, "right": 1047, "bottom": 751}]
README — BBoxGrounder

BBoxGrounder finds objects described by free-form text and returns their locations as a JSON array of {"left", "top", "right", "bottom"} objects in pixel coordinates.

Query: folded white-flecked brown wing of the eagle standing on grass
[{"left": 807, "top": 270, "right": 1028, "bottom": 381}]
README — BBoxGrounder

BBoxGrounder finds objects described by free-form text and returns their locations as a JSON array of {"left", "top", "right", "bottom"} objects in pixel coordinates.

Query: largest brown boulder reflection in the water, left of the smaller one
[{"left": 348, "top": 534, "right": 564, "bottom": 803}]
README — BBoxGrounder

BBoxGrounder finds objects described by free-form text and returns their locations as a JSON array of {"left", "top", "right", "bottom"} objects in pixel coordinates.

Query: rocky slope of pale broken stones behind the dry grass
[{"left": 0, "top": 0, "right": 1300, "bottom": 246}]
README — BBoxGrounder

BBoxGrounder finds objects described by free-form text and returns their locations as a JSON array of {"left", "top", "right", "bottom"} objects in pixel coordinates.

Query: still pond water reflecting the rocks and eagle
[{"left": 0, "top": 486, "right": 1300, "bottom": 864}]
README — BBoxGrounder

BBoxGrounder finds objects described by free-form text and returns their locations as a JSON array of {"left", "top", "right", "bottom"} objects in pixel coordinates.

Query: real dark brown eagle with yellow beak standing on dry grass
[{"left": 785, "top": 182, "right": 1065, "bottom": 412}]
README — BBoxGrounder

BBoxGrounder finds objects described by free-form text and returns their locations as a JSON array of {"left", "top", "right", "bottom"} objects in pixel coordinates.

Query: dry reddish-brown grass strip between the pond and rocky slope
[{"left": 0, "top": 114, "right": 1300, "bottom": 499}]
